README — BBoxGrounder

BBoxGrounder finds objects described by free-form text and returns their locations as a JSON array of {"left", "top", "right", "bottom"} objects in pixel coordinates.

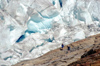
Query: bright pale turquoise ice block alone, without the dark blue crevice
[{"left": 27, "top": 19, "right": 52, "bottom": 33}]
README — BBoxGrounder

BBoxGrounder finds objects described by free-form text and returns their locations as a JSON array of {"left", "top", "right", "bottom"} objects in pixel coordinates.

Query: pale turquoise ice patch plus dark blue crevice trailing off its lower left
[{"left": 16, "top": 19, "right": 52, "bottom": 42}]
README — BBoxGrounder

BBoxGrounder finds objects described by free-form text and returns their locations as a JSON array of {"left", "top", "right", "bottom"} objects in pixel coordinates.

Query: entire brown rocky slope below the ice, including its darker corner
[{"left": 12, "top": 34, "right": 100, "bottom": 66}]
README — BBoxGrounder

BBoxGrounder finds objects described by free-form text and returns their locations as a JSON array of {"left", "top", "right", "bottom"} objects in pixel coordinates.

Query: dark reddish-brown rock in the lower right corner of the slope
[{"left": 68, "top": 44, "right": 100, "bottom": 66}]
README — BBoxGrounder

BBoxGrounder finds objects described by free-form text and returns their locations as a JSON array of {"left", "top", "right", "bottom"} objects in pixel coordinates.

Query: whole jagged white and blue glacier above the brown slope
[{"left": 0, "top": 0, "right": 100, "bottom": 66}]
